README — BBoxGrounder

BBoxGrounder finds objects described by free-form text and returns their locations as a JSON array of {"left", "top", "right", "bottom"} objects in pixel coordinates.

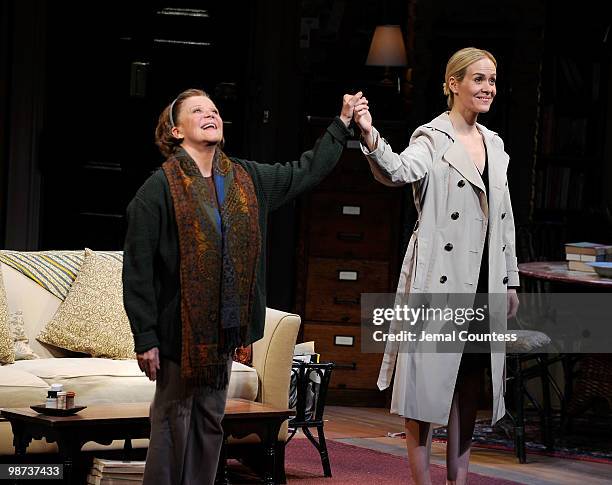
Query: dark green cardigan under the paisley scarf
[{"left": 123, "top": 117, "right": 352, "bottom": 362}]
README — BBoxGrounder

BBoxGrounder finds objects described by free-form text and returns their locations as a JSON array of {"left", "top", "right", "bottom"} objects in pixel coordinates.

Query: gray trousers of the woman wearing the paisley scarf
[{"left": 143, "top": 359, "right": 232, "bottom": 485}]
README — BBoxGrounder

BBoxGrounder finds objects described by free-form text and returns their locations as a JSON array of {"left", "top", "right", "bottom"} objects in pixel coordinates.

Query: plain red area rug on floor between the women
[{"left": 229, "top": 439, "right": 518, "bottom": 485}]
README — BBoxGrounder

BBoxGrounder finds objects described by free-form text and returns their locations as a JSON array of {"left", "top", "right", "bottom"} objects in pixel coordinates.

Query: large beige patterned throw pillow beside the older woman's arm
[{"left": 37, "top": 248, "right": 136, "bottom": 359}]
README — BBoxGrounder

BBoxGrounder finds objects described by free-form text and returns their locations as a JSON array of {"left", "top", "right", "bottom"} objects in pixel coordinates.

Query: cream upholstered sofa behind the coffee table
[{"left": 0, "top": 263, "right": 300, "bottom": 455}]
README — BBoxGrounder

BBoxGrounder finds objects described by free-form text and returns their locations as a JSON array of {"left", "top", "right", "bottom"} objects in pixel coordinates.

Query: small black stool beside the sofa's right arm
[{"left": 286, "top": 362, "right": 334, "bottom": 477}]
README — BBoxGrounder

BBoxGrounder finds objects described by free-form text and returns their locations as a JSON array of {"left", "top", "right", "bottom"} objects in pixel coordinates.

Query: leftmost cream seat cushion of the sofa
[{"left": 0, "top": 364, "right": 49, "bottom": 408}]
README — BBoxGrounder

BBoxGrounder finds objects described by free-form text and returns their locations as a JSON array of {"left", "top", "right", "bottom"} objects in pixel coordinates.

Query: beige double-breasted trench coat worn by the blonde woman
[{"left": 362, "top": 112, "right": 519, "bottom": 425}]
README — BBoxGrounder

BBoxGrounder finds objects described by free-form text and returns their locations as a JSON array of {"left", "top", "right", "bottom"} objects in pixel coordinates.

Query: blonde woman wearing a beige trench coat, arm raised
[{"left": 355, "top": 48, "right": 519, "bottom": 484}]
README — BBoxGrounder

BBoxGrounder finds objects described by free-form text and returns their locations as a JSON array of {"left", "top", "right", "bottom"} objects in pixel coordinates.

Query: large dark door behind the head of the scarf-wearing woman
[{"left": 40, "top": 0, "right": 253, "bottom": 250}]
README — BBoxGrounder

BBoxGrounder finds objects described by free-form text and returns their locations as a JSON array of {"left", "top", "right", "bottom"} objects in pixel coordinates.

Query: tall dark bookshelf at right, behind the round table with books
[{"left": 532, "top": 14, "right": 609, "bottom": 227}]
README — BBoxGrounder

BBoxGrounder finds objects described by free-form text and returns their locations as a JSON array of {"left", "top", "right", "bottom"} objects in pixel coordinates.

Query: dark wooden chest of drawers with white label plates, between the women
[{"left": 296, "top": 117, "right": 410, "bottom": 406}]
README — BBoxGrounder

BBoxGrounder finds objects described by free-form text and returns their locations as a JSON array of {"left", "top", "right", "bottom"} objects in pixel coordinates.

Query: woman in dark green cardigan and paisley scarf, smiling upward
[{"left": 123, "top": 89, "right": 366, "bottom": 485}]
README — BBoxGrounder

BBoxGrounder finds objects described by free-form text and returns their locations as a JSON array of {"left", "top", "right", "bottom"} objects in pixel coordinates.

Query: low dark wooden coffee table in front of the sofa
[{"left": 1, "top": 399, "right": 291, "bottom": 484}]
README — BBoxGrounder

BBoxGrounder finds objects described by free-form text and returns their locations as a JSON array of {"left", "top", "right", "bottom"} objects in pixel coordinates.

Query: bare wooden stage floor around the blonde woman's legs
[{"left": 290, "top": 406, "right": 612, "bottom": 485}]
